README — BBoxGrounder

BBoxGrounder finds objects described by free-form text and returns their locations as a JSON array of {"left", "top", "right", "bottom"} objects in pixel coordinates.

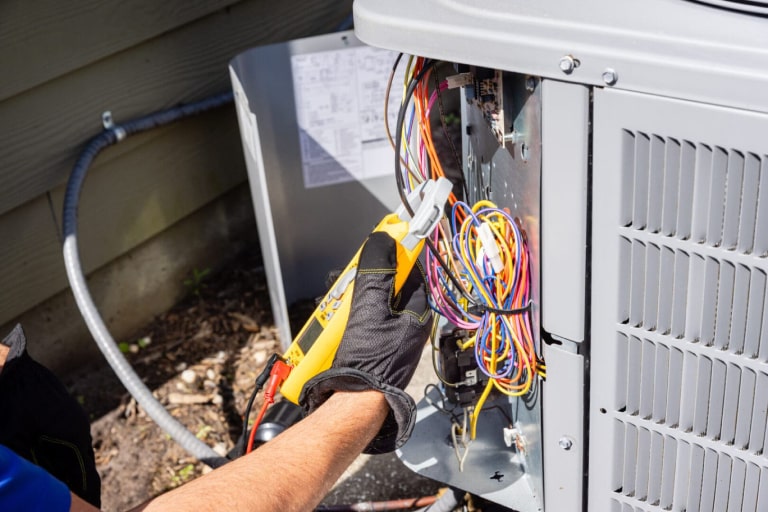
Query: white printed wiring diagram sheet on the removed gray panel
[{"left": 291, "top": 46, "right": 403, "bottom": 188}]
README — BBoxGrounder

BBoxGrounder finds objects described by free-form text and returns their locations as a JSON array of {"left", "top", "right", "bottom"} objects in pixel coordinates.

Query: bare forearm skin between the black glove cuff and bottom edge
[{"left": 132, "top": 391, "right": 389, "bottom": 512}]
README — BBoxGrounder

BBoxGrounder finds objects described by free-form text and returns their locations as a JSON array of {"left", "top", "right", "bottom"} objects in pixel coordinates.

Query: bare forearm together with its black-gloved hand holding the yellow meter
[{"left": 132, "top": 233, "right": 431, "bottom": 511}]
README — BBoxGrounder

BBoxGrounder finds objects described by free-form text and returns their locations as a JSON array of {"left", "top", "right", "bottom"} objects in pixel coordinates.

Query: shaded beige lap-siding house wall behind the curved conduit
[{"left": 0, "top": 0, "right": 351, "bottom": 372}]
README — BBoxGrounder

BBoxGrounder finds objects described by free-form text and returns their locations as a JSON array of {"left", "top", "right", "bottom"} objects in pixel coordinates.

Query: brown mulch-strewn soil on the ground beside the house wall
[{"left": 67, "top": 247, "right": 439, "bottom": 511}]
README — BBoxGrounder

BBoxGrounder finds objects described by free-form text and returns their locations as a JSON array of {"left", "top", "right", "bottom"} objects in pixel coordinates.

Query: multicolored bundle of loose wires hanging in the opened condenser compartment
[{"left": 385, "top": 55, "right": 546, "bottom": 439}]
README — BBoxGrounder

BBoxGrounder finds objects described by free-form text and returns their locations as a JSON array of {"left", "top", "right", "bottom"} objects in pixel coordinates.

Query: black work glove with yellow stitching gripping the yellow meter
[{"left": 299, "top": 232, "right": 432, "bottom": 453}]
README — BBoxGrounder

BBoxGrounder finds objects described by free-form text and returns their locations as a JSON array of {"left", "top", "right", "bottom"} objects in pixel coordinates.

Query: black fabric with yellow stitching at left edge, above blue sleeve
[{"left": 0, "top": 326, "right": 101, "bottom": 507}]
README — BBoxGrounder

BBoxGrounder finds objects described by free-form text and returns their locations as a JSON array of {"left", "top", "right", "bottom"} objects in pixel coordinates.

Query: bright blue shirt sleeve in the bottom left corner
[{"left": 0, "top": 445, "right": 72, "bottom": 512}]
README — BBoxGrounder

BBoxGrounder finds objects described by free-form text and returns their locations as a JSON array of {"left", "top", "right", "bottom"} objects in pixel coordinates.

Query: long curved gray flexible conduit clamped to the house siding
[{"left": 62, "top": 92, "right": 233, "bottom": 468}]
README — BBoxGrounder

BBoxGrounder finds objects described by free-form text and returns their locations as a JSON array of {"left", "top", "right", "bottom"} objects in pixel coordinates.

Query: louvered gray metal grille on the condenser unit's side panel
[{"left": 611, "top": 130, "right": 768, "bottom": 512}]
